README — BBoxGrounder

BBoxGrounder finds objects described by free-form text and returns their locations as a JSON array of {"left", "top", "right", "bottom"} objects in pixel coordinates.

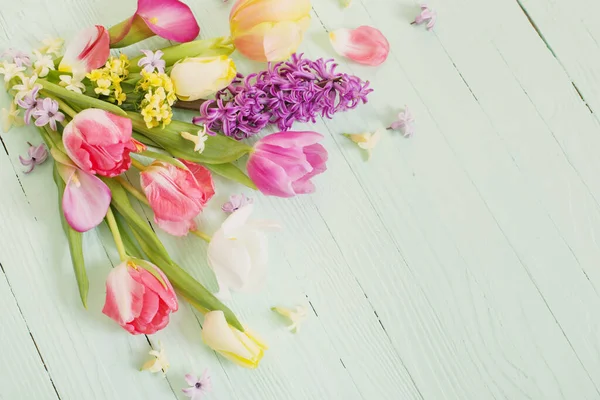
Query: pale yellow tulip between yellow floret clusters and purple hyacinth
[{"left": 171, "top": 56, "right": 236, "bottom": 101}]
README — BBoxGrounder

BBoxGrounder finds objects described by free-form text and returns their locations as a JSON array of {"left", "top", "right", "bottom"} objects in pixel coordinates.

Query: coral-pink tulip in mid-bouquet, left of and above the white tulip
[{"left": 140, "top": 161, "right": 215, "bottom": 236}]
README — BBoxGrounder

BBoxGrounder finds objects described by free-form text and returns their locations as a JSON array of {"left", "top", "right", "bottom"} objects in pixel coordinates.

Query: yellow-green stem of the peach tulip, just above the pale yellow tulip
[{"left": 129, "top": 37, "right": 235, "bottom": 73}]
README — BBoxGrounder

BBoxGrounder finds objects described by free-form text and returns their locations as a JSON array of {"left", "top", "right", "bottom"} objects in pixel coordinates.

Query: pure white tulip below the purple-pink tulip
[{"left": 207, "top": 204, "right": 279, "bottom": 299}]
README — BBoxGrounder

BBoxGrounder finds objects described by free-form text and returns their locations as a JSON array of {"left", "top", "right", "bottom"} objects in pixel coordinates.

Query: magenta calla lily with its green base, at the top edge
[{"left": 110, "top": 0, "right": 200, "bottom": 48}]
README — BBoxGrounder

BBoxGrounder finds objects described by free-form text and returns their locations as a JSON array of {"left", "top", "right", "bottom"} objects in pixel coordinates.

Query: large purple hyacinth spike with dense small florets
[{"left": 193, "top": 54, "right": 373, "bottom": 140}]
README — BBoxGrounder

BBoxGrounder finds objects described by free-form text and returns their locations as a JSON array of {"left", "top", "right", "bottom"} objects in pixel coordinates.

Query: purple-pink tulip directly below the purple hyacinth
[{"left": 247, "top": 132, "right": 327, "bottom": 197}]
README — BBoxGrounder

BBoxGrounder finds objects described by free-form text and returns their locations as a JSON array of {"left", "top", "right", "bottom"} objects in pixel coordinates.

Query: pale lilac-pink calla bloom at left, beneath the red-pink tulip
[{"left": 62, "top": 168, "right": 111, "bottom": 232}]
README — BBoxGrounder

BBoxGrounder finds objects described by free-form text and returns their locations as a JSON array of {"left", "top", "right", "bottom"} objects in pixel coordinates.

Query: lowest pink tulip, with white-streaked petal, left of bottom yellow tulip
[{"left": 102, "top": 260, "right": 179, "bottom": 335}]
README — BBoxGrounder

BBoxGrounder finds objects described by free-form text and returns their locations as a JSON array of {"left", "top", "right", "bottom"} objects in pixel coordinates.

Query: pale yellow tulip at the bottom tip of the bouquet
[{"left": 202, "top": 310, "right": 267, "bottom": 368}]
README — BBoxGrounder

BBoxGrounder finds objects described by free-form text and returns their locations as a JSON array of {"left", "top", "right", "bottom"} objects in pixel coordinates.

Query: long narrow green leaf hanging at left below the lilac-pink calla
[{"left": 54, "top": 163, "right": 90, "bottom": 309}]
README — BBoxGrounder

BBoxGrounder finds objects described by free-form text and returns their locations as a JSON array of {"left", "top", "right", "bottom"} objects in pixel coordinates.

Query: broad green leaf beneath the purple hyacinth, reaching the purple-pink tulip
[{"left": 127, "top": 112, "right": 252, "bottom": 164}]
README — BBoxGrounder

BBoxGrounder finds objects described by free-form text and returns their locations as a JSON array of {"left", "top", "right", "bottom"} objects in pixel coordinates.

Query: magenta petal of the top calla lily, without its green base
[{"left": 137, "top": 0, "right": 200, "bottom": 42}]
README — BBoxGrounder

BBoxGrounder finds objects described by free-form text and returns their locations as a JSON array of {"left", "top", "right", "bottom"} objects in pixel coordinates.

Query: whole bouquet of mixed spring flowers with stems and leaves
[{"left": 0, "top": 0, "right": 371, "bottom": 367}]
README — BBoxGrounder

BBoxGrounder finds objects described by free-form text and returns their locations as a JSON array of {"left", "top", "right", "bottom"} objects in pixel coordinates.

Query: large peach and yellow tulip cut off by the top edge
[{"left": 229, "top": 0, "right": 311, "bottom": 61}]
